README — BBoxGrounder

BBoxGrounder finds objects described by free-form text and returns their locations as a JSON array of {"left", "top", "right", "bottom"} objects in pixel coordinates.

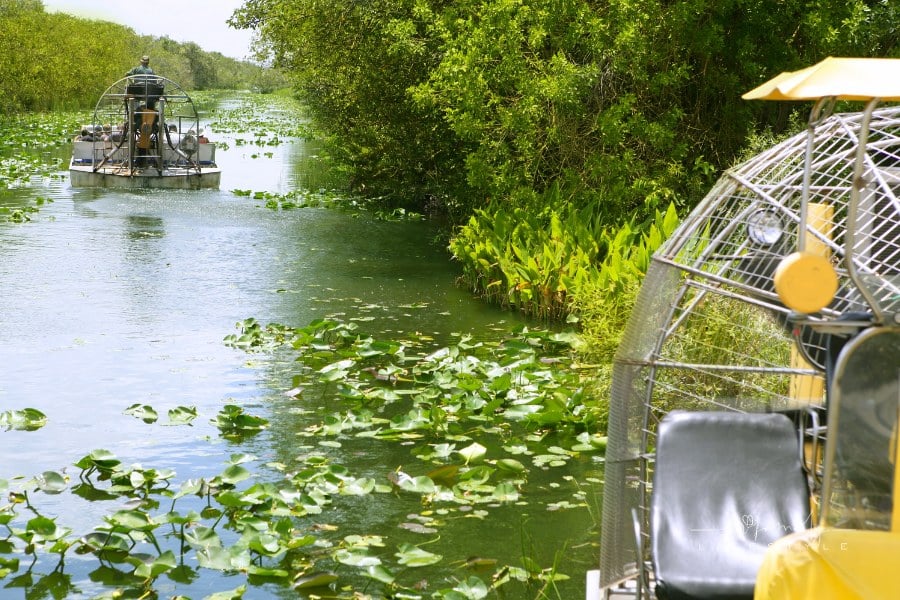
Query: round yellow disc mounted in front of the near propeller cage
[{"left": 774, "top": 252, "right": 838, "bottom": 314}]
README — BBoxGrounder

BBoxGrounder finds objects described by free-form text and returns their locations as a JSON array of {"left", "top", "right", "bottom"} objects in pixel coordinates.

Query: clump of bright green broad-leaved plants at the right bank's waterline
[{"left": 450, "top": 199, "right": 678, "bottom": 320}]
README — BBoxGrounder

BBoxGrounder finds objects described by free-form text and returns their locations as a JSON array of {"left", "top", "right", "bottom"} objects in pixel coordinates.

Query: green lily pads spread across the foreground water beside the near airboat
[{"left": 0, "top": 319, "right": 605, "bottom": 599}]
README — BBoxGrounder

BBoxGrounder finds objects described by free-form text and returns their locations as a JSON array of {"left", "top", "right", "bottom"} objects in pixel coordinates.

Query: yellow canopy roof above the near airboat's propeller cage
[{"left": 741, "top": 56, "right": 900, "bottom": 100}]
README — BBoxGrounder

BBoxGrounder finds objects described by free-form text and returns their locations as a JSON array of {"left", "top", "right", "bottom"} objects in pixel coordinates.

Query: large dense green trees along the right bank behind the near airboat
[{"left": 233, "top": 0, "right": 898, "bottom": 324}]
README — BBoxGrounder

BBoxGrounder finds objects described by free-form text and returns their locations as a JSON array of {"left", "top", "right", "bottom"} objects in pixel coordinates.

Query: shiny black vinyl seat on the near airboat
[{"left": 650, "top": 411, "right": 810, "bottom": 600}]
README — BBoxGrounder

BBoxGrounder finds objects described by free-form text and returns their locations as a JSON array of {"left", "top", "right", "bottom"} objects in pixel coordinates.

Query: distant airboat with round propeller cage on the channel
[{"left": 69, "top": 75, "right": 222, "bottom": 189}]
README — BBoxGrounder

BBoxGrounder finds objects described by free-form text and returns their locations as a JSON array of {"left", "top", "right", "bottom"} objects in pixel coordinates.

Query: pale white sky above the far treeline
[{"left": 43, "top": 0, "right": 252, "bottom": 59}]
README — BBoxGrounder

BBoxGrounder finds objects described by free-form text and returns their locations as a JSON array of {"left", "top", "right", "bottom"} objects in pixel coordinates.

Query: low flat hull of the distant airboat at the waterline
[{"left": 69, "top": 165, "right": 222, "bottom": 190}]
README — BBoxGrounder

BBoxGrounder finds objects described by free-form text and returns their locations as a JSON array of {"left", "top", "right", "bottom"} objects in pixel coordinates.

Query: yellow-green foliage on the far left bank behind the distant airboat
[{"left": 0, "top": 0, "right": 278, "bottom": 115}]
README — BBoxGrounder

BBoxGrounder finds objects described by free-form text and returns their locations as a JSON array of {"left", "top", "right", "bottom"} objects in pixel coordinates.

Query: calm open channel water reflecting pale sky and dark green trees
[{"left": 0, "top": 105, "right": 597, "bottom": 598}]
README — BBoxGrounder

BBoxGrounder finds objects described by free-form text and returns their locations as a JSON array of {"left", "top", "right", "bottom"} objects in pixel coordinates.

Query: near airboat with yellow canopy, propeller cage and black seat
[{"left": 587, "top": 58, "right": 900, "bottom": 600}]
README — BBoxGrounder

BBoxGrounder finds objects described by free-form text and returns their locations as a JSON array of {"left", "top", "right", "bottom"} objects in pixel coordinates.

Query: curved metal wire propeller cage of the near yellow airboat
[{"left": 600, "top": 107, "right": 900, "bottom": 587}]
